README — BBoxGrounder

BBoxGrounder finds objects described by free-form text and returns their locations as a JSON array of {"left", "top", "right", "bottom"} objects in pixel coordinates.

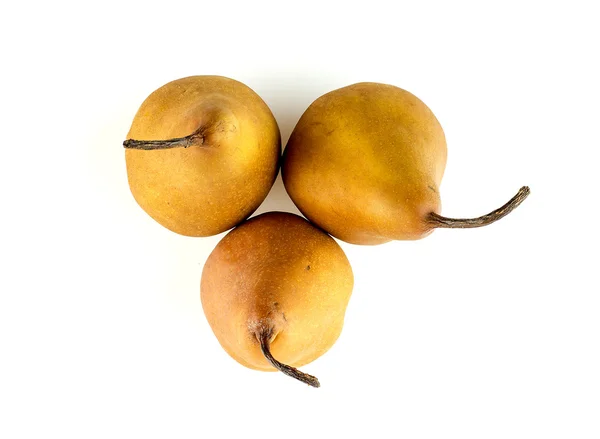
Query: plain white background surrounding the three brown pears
[{"left": 0, "top": 1, "right": 600, "bottom": 439}]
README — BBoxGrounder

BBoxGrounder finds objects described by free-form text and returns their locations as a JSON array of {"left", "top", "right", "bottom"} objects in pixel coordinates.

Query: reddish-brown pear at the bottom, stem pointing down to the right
[{"left": 200, "top": 212, "right": 354, "bottom": 387}]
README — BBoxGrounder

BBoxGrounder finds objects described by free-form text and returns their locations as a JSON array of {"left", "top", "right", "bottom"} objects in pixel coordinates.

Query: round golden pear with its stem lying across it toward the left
[{"left": 123, "top": 76, "right": 281, "bottom": 236}]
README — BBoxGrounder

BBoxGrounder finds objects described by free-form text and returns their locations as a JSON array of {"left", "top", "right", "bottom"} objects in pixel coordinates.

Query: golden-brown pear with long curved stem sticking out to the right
[{"left": 282, "top": 83, "right": 529, "bottom": 245}]
